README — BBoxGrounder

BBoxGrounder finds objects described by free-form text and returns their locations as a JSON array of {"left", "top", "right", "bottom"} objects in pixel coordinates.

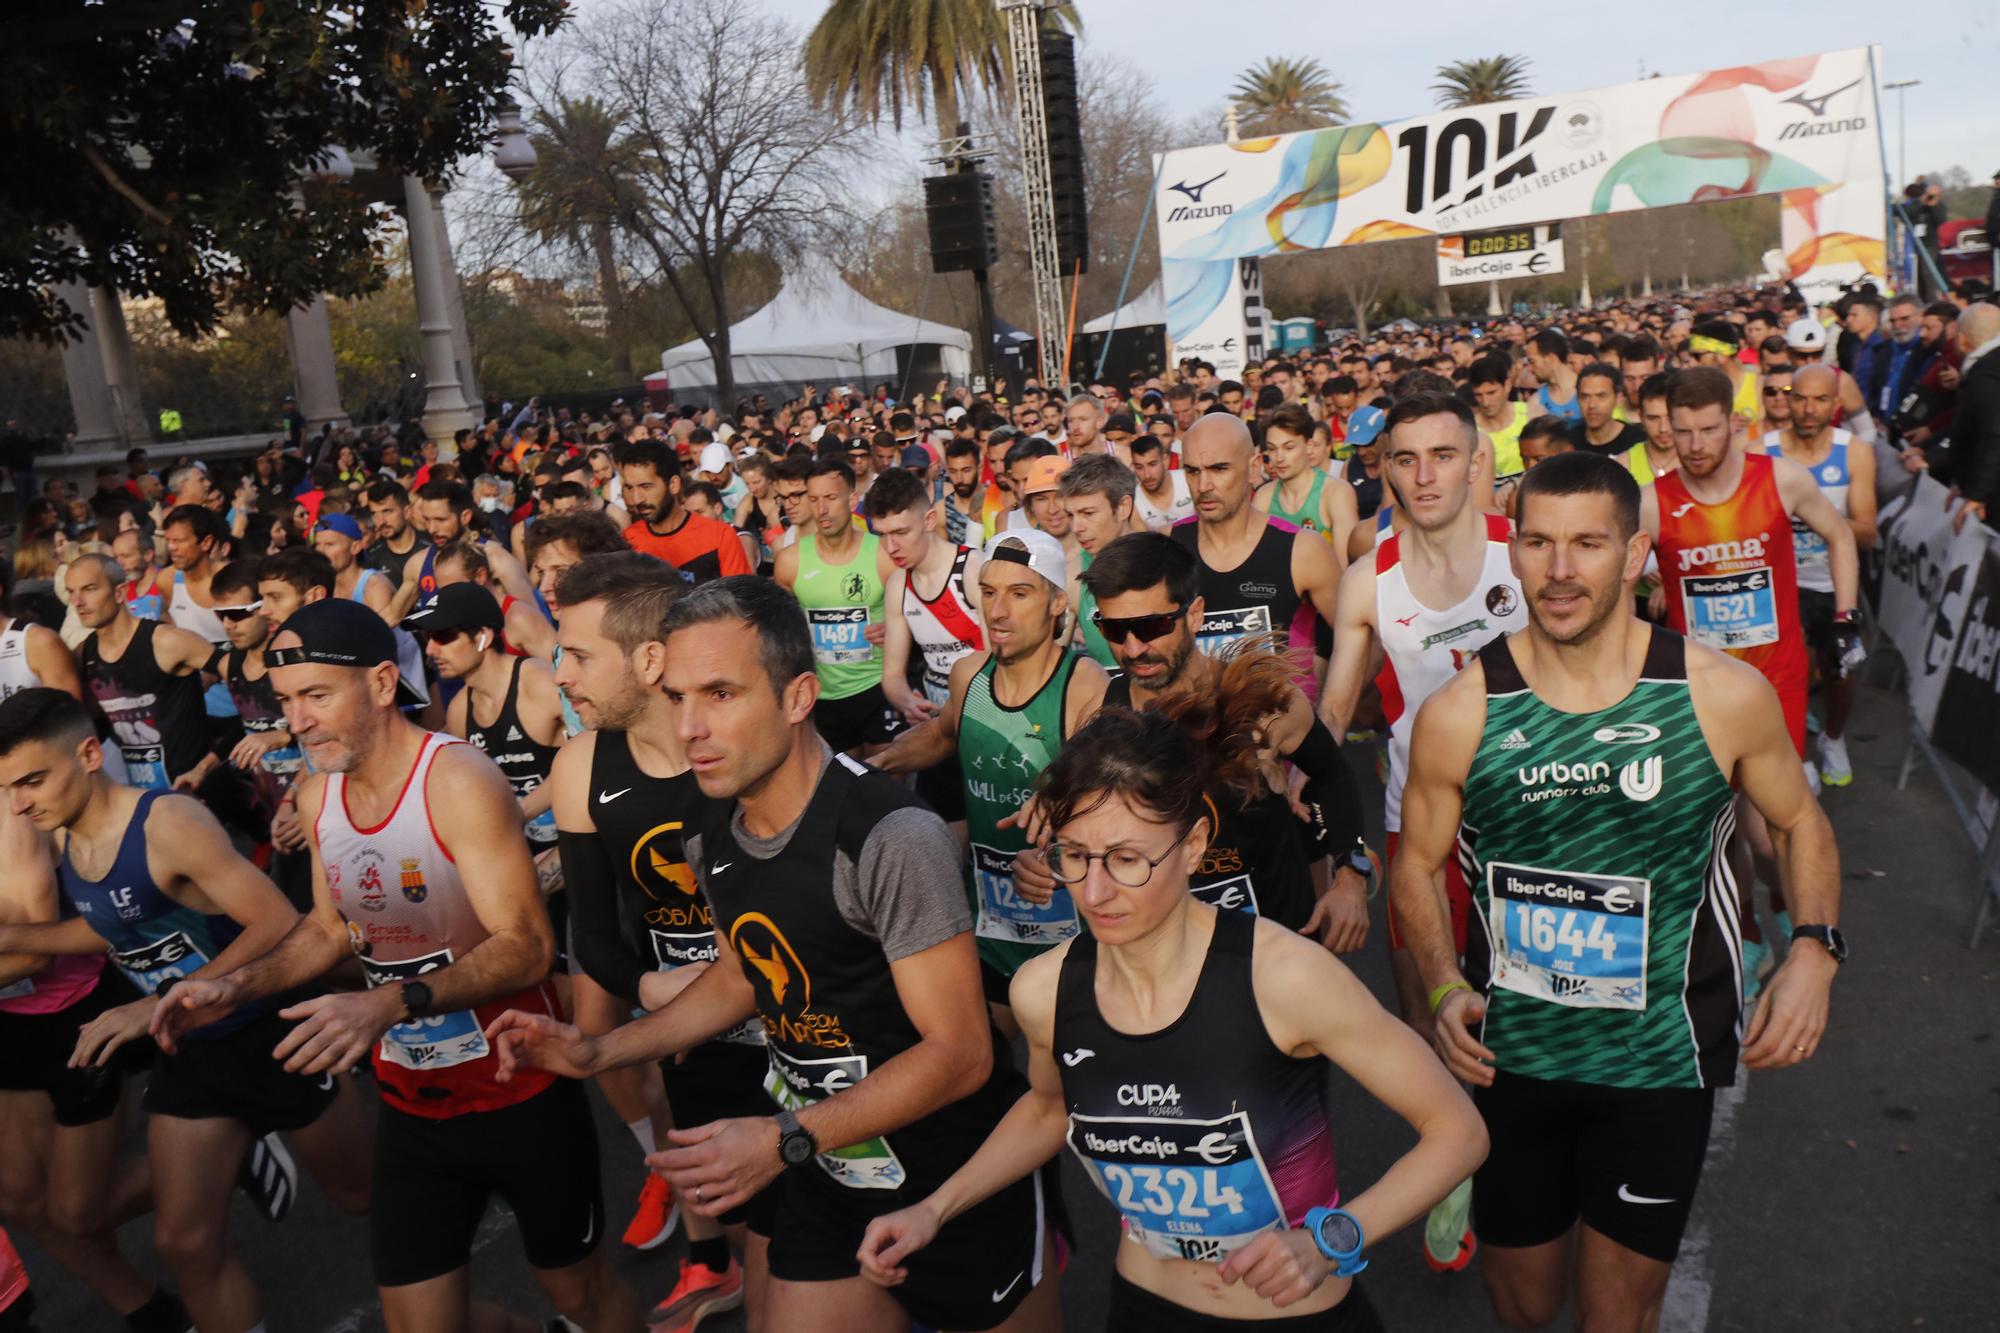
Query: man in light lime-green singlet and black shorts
[{"left": 772, "top": 454, "right": 902, "bottom": 757}]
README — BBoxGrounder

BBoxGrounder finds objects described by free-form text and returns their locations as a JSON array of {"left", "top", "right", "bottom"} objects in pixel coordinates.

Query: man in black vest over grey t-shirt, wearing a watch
[{"left": 494, "top": 578, "right": 1060, "bottom": 1333}]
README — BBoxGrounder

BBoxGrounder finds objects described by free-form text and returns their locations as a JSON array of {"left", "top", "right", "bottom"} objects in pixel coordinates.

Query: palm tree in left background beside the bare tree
[{"left": 518, "top": 98, "right": 636, "bottom": 382}]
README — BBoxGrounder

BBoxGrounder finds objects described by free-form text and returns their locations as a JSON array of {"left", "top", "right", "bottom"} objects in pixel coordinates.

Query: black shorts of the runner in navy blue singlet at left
[{"left": 140, "top": 1011, "right": 340, "bottom": 1137}]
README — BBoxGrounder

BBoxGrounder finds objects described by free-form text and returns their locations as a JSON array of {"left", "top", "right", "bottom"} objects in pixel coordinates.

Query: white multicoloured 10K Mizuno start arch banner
[{"left": 1154, "top": 46, "right": 1886, "bottom": 376}]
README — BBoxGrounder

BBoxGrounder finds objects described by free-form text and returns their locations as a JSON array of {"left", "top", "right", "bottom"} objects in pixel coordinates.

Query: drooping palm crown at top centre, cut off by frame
[{"left": 804, "top": 0, "right": 1078, "bottom": 134}]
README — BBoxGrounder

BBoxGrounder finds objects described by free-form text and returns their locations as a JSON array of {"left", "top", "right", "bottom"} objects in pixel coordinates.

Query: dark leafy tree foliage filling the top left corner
[{"left": 0, "top": 0, "right": 566, "bottom": 338}]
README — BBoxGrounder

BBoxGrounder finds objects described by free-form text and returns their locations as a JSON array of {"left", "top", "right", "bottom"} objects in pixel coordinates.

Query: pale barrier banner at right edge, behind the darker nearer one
[{"left": 1876, "top": 474, "right": 1986, "bottom": 733}]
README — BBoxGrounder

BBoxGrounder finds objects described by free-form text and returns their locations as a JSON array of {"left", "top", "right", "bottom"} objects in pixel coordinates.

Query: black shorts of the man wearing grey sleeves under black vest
[{"left": 770, "top": 1163, "right": 1054, "bottom": 1333}]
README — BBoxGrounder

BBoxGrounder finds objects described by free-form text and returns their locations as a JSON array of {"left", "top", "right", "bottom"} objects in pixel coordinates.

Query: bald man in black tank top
[{"left": 1172, "top": 412, "right": 1342, "bottom": 676}]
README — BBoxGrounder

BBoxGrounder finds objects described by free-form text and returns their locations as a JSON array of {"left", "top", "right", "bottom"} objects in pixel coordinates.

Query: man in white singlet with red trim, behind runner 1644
[{"left": 1320, "top": 392, "right": 1528, "bottom": 1273}]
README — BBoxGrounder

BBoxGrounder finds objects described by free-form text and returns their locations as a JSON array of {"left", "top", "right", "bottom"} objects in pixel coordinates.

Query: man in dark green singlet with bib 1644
[{"left": 1392, "top": 452, "right": 1846, "bottom": 1329}]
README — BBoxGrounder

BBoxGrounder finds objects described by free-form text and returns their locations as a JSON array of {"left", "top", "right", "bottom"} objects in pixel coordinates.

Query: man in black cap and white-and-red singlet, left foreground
[{"left": 154, "top": 598, "right": 640, "bottom": 1333}]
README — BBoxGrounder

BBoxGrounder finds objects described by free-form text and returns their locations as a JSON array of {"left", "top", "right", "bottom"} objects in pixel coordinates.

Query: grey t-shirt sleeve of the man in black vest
[{"left": 834, "top": 807, "right": 972, "bottom": 963}]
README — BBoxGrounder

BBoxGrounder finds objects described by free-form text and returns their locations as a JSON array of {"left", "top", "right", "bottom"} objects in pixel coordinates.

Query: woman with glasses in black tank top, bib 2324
[{"left": 862, "top": 709, "right": 1484, "bottom": 1333}]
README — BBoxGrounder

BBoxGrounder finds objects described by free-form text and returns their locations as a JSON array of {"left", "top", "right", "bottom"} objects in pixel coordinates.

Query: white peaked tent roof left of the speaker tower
[{"left": 660, "top": 262, "right": 972, "bottom": 388}]
